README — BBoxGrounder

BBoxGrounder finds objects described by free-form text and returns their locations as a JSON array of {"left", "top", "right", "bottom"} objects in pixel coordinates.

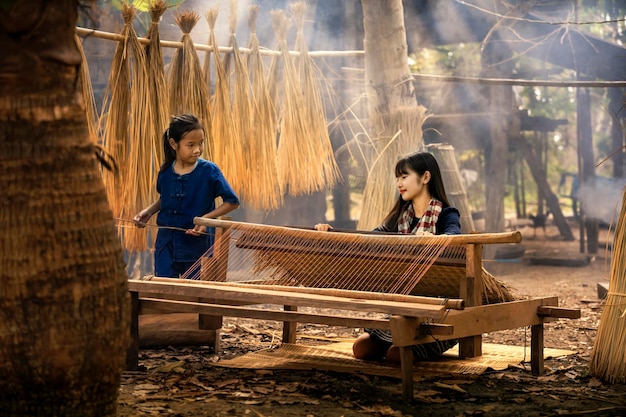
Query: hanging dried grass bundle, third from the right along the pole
[{"left": 246, "top": 5, "right": 283, "bottom": 210}]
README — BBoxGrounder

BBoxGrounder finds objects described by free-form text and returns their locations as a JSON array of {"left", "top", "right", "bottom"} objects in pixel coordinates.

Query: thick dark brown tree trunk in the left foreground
[{"left": 0, "top": 0, "right": 129, "bottom": 416}]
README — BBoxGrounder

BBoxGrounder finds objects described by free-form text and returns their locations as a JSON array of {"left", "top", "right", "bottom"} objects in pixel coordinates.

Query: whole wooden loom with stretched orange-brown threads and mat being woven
[{"left": 127, "top": 218, "right": 580, "bottom": 401}]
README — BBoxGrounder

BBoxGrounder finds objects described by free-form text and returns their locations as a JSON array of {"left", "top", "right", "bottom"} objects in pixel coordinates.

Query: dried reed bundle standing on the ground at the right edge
[{"left": 589, "top": 189, "right": 626, "bottom": 384}]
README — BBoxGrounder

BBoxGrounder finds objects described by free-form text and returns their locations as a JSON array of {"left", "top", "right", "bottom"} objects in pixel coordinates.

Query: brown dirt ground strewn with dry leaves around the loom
[{"left": 118, "top": 219, "right": 626, "bottom": 417}]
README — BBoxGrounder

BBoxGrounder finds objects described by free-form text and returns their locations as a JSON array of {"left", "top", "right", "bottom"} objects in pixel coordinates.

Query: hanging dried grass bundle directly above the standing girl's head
[{"left": 167, "top": 11, "right": 215, "bottom": 159}]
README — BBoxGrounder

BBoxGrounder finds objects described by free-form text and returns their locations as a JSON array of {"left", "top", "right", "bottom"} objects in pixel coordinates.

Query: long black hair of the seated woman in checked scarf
[{"left": 382, "top": 152, "right": 450, "bottom": 230}]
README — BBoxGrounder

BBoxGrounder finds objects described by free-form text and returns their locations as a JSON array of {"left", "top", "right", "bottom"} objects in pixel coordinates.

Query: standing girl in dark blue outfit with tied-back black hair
[{"left": 133, "top": 114, "right": 239, "bottom": 278}]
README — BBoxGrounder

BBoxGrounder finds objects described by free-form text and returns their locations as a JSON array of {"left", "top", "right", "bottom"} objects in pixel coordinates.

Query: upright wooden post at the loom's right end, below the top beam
[{"left": 459, "top": 244, "right": 483, "bottom": 358}]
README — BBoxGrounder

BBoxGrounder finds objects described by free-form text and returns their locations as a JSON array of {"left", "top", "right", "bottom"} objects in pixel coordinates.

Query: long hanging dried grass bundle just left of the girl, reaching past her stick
[{"left": 101, "top": 3, "right": 153, "bottom": 250}]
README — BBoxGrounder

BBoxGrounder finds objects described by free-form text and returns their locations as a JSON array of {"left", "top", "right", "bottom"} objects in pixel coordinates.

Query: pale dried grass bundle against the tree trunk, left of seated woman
[{"left": 357, "top": 106, "right": 426, "bottom": 230}]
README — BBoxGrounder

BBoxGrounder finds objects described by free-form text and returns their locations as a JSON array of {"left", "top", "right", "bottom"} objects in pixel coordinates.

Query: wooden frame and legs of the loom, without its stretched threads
[{"left": 127, "top": 218, "right": 580, "bottom": 401}]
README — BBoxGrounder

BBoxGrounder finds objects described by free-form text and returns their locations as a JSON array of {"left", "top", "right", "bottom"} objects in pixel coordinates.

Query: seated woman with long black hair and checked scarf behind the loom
[{"left": 315, "top": 152, "right": 461, "bottom": 362}]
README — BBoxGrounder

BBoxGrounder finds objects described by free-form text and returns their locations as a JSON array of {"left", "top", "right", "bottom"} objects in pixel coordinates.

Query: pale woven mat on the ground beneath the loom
[{"left": 215, "top": 342, "right": 575, "bottom": 381}]
